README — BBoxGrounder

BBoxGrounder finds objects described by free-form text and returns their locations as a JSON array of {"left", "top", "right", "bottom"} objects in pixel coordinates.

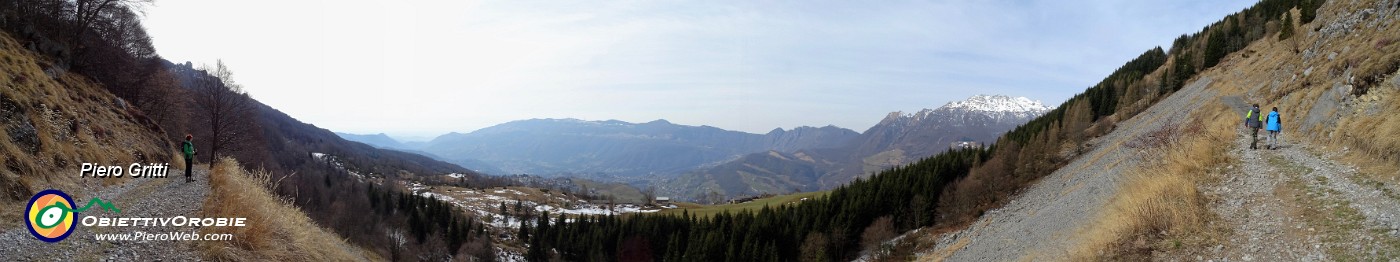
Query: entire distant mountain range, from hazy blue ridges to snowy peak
[{"left": 337, "top": 95, "right": 1049, "bottom": 199}]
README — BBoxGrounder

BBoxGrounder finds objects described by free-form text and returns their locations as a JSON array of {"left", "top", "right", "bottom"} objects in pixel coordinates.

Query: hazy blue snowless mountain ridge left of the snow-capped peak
[{"left": 417, "top": 119, "right": 860, "bottom": 178}]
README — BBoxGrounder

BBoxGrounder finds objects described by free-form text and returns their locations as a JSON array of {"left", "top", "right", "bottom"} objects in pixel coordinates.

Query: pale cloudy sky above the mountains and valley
[{"left": 144, "top": 0, "right": 1254, "bottom": 139}]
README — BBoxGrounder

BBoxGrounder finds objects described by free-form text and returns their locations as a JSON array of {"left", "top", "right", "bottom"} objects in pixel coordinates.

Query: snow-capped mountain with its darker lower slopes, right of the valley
[{"left": 655, "top": 95, "right": 1050, "bottom": 199}]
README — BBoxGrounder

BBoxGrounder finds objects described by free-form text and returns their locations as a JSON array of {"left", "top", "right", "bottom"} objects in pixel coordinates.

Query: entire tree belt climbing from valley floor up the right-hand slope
[{"left": 519, "top": 0, "right": 1323, "bottom": 261}]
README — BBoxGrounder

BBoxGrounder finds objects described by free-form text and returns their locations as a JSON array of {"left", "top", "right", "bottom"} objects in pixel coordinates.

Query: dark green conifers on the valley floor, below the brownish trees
[{"left": 519, "top": 149, "right": 987, "bottom": 261}]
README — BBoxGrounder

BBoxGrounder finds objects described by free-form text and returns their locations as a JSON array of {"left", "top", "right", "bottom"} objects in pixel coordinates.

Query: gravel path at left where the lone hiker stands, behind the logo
[{"left": 0, "top": 167, "right": 209, "bottom": 261}]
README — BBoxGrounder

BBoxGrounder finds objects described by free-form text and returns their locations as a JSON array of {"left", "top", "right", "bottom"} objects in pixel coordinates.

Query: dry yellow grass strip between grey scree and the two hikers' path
[{"left": 1070, "top": 104, "right": 1236, "bottom": 261}]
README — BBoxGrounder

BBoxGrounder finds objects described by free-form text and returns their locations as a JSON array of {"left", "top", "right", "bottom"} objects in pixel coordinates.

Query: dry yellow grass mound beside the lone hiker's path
[{"left": 199, "top": 158, "right": 374, "bottom": 261}]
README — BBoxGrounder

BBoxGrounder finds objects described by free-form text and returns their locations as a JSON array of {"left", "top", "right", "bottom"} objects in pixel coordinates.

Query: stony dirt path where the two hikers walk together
[{"left": 1156, "top": 102, "right": 1400, "bottom": 261}]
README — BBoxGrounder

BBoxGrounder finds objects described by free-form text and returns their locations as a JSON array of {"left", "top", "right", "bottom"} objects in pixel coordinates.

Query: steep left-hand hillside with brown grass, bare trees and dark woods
[{"left": 0, "top": 0, "right": 507, "bottom": 261}]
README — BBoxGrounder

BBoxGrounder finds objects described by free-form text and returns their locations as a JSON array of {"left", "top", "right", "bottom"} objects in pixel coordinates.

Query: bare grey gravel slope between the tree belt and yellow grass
[{"left": 920, "top": 77, "right": 1217, "bottom": 261}]
